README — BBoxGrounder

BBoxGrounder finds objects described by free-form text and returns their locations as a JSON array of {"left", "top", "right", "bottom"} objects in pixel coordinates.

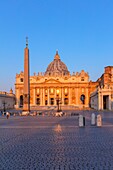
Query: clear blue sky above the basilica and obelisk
[{"left": 0, "top": 0, "right": 113, "bottom": 92}]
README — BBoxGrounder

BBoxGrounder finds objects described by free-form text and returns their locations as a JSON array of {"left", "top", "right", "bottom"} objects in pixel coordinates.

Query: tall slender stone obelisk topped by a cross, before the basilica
[{"left": 22, "top": 37, "right": 30, "bottom": 115}]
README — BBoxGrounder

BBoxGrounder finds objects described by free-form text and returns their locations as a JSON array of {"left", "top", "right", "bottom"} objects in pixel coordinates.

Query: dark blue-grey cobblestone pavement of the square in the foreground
[{"left": 0, "top": 111, "right": 113, "bottom": 170}]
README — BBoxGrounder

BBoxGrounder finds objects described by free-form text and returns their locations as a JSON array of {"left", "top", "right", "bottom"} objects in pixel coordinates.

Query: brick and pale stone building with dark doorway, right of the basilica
[{"left": 90, "top": 66, "right": 113, "bottom": 110}]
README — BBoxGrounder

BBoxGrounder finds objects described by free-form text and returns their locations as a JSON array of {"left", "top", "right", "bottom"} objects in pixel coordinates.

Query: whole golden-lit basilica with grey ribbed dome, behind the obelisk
[{"left": 15, "top": 46, "right": 99, "bottom": 109}]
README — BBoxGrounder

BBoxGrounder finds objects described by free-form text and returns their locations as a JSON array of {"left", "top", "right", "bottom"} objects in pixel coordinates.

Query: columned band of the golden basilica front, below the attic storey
[{"left": 16, "top": 86, "right": 89, "bottom": 108}]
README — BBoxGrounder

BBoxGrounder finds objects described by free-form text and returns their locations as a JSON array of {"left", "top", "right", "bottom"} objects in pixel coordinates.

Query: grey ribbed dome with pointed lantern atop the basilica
[{"left": 45, "top": 51, "right": 70, "bottom": 76}]
